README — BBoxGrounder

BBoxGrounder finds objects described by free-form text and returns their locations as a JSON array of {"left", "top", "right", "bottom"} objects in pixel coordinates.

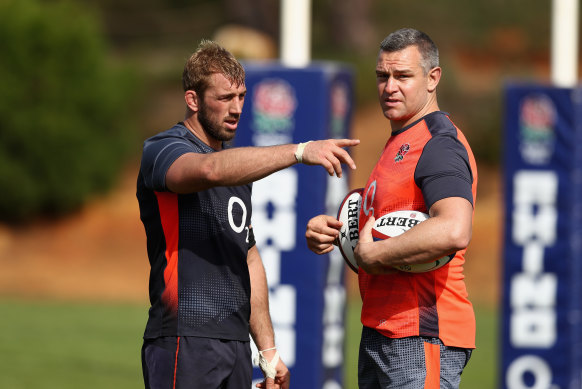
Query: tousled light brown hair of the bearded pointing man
[{"left": 182, "top": 39, "right": 245, "bottom": 98}]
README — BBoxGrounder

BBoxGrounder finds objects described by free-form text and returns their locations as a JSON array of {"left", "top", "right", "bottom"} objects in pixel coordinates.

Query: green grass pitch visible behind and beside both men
[{"left": 0, "top": 300, "right": 497, "bottom": 389}]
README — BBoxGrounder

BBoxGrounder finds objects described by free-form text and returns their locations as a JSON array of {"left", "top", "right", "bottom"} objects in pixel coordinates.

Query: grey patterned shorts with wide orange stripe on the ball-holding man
[{"left": 358, "top": 327, "right": 472, "bottom": 389}]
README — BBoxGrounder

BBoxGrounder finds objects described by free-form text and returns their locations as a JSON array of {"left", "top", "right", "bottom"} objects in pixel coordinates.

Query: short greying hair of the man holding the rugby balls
[{"left": 380, "top": 28, "right": 439, "bottom": 74}]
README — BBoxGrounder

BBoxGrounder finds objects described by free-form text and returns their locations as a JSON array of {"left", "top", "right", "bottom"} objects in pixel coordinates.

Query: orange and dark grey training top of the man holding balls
[{"left": 358, "top": 111, "right": 477, "bottom": 348}]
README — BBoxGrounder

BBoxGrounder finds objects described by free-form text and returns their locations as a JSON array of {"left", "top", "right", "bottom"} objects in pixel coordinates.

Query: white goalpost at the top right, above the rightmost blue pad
[{"left": 551, "top": 0, "right": 579, "bottom": 88}]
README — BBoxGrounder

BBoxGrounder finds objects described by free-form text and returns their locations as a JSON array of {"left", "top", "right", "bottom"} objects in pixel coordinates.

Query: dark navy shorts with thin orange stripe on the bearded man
[{"left": 141, "top": 336, "right": 253, "bottom": 389}]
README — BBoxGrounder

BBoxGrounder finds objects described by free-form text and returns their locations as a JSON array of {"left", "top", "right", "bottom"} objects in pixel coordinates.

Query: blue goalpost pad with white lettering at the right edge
[{"left": 500, "top": 85, "right": 582, "bottom": 389}]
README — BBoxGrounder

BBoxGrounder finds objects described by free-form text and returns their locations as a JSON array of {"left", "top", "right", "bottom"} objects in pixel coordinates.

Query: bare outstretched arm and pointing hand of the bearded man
[{"left": 166, "top": 139, "right": 360, "bottom": 193}]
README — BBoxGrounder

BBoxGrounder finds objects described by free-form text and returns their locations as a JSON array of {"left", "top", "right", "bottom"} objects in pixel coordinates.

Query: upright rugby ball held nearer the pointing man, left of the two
[{"left": 337, "top": 188, "right": 364, "bottom": 273}]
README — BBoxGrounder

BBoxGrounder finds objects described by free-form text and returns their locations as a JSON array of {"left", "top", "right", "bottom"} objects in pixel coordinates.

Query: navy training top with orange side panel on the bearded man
[{"left": 136, "top": 123, "right": 254, "bottom": 341}]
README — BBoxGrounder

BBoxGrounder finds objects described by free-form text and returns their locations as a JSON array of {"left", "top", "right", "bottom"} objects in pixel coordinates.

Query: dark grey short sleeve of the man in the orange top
[{"left": 414, "top": 135, "right": 474, "bottom": 209}]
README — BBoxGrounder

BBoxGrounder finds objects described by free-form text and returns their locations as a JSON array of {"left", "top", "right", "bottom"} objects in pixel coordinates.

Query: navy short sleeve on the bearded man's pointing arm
[{"left": 140, "top": 137, "right": 194, "bottom": 191}]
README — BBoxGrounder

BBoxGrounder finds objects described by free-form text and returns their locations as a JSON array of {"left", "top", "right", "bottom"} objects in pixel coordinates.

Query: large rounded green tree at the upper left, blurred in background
[{"left": 0, "top": 0, "right": 136, "bottom": 222}]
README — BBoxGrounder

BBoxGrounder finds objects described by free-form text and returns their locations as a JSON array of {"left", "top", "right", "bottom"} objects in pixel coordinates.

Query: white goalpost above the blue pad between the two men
[{"left": 280, "top": 0, "right": 311, "bottom": 67}]
